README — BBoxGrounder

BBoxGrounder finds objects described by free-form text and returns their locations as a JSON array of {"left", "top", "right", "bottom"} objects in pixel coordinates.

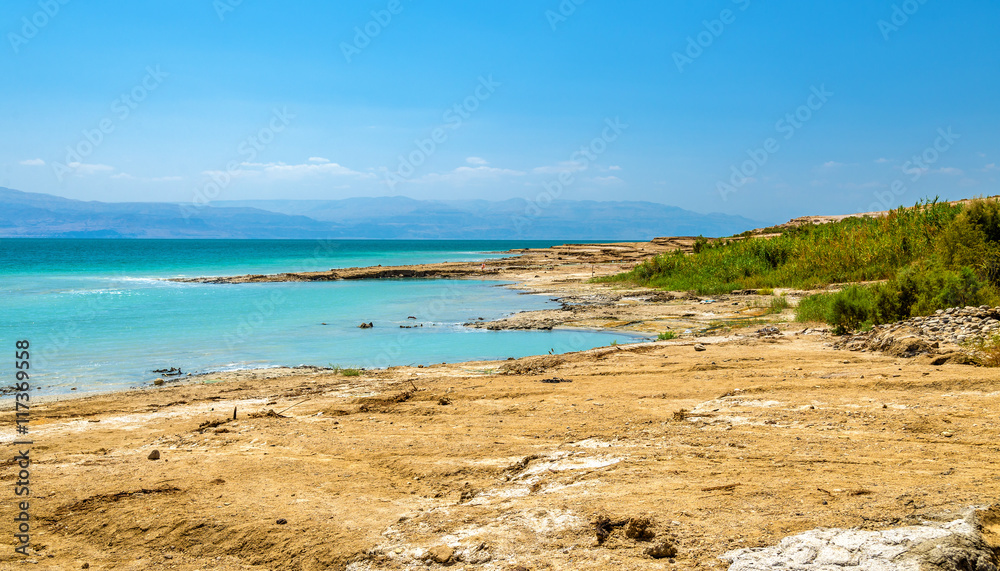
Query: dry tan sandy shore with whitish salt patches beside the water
[{"left": 0, "top": 239, "right": 1000, "bottom": 570}]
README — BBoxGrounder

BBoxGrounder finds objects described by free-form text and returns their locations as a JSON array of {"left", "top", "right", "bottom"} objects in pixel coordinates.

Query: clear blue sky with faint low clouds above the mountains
[{"left": 0, "top": 0, "right": 1000, "bottom": 222}]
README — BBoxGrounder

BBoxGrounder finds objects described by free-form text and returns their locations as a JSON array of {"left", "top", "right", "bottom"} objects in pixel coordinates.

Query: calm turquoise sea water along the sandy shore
[{"left": 0, "top": 239, "right": 634, "bottom": 394}]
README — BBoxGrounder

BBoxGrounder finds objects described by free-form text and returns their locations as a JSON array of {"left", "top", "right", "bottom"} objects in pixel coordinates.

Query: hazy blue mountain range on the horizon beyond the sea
[{"left": 0, "top": 187, "right": 764, "bottom": 240}]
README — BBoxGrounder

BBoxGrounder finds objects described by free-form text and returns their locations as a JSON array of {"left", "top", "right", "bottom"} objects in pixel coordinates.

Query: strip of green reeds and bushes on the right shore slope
[{"left": 593, "top": 198, "right": 1000, "bottom": 333}]
